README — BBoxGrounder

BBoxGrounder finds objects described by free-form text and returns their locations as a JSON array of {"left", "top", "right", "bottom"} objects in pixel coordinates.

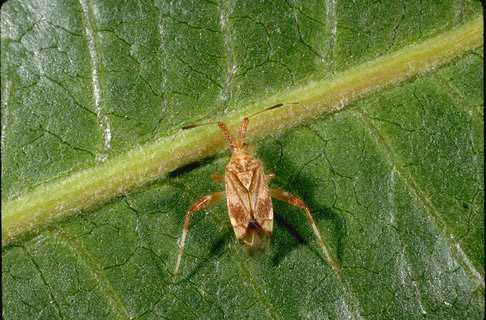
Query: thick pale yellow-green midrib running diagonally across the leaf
[{"left": 2, "top": 16, "right": 483, "bottom": 246}]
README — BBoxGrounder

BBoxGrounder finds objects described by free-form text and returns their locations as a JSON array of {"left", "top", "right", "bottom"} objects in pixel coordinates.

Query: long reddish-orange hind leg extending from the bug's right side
[{"left": 270, "top": 189, "right": 340, "bottom": 274}]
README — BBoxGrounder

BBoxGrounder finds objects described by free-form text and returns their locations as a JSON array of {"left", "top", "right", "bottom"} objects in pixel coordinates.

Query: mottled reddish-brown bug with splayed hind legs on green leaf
[{"left": 174, "top": 118, "right": 339, "bottom": 274}]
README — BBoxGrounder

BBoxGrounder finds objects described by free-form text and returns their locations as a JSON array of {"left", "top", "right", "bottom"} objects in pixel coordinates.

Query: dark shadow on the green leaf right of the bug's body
[{"left": 257, "top": 141, "right": 347, "bottom": 265}]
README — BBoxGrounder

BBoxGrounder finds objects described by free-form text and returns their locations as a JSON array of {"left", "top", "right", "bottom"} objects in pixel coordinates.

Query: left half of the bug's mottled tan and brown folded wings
[{"left": 224, "top": 169, "right": 251, "bottom": 239}]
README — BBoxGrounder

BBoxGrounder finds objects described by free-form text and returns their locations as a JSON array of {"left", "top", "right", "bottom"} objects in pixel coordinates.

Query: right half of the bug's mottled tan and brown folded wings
[{"left": 249, "top": 165, "right": 273, "bottom": 233}]
